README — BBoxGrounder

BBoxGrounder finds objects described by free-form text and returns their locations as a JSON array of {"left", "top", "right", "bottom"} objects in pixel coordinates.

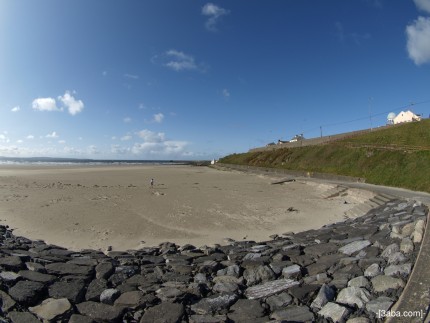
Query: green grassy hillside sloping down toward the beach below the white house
[{"left": 220, "top": 119, "right": 430, "bottom": 192}]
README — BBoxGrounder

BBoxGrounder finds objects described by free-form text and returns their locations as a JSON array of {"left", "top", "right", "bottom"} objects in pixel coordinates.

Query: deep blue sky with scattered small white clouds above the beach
[{"left": 0, "top": 0, "right": 430, "bottom": 159}]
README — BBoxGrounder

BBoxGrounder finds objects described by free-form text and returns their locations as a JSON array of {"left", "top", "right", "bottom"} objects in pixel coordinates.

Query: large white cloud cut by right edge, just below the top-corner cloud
[{"left": 406, "top": 17, "right": 430, "bottom": 65}]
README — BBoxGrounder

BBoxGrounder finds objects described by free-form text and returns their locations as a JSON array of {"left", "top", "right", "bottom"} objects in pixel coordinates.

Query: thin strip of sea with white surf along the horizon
[{"left": 0, "top": 156, "right": 202, "bottom": 166}]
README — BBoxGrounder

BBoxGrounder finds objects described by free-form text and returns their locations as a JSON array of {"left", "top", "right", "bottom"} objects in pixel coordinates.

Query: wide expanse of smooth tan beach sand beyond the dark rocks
[{"left": 0, "top": 165, "right": 373, "bottom": 250}]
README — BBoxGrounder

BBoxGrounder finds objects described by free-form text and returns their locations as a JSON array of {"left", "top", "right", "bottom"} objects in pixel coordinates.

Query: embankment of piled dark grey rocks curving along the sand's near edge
[{"left": 0, "top": 200, "right": 428, "bottom": 323}]
